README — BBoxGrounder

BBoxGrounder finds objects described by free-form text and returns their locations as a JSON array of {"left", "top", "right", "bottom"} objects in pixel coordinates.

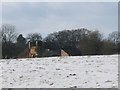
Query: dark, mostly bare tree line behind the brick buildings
[{"left": 0, "top": 24, "right": 120, "bottom": 58}]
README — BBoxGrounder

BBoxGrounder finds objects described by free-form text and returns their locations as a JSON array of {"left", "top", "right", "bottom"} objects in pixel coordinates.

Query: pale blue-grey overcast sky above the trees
[{"left": 2, "top": 2, "right": 118, "bottom": 37}]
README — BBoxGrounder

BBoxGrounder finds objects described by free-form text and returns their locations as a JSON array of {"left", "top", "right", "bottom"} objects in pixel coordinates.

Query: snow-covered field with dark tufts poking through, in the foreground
[{"left": 0, "top": 55, "right": 118, "bottom": 88}]
